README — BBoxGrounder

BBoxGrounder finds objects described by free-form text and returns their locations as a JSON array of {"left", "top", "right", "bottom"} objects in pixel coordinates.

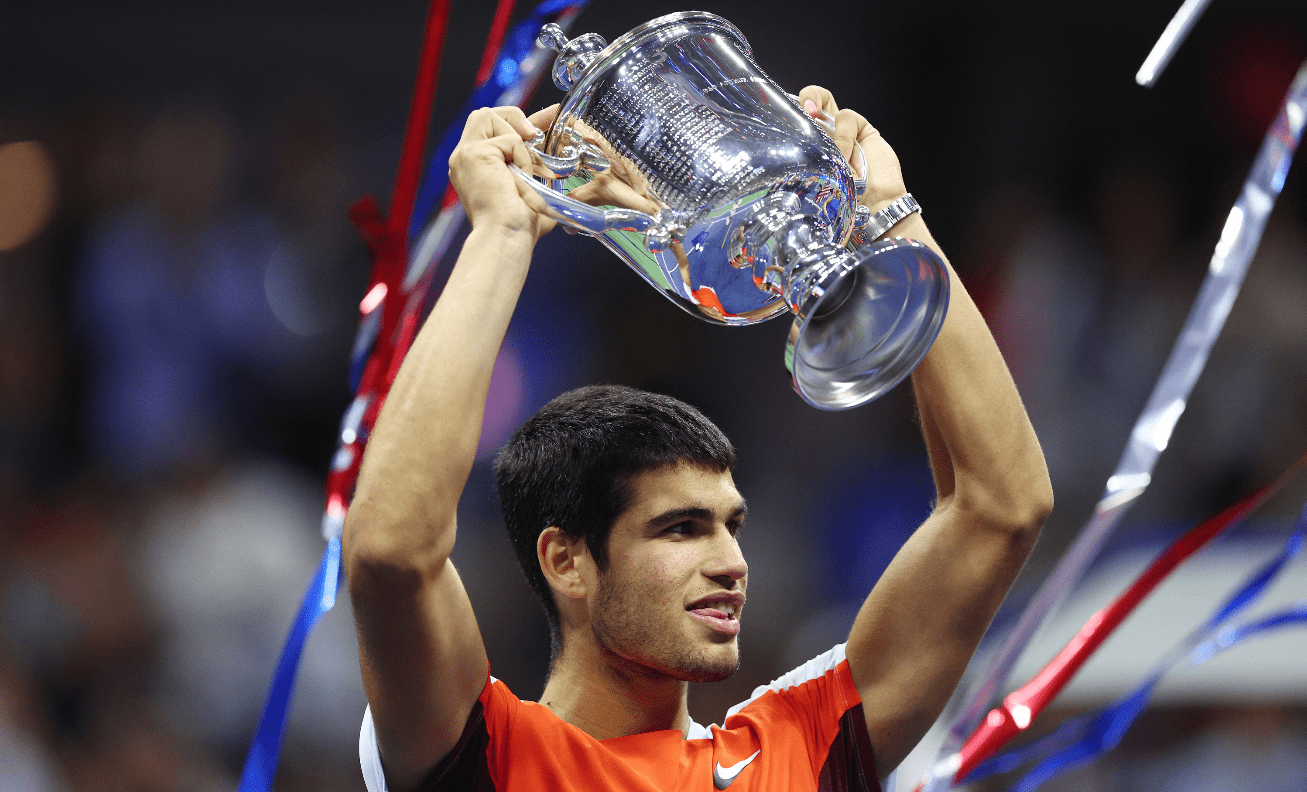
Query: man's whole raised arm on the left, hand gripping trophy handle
[{"left": 344, "top": 107, "right": 553, "bottom": 792}]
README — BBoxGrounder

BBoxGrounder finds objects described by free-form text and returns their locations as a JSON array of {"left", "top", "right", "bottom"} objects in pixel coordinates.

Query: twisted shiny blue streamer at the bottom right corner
[{"left": 966, "top": 507, "right": 1307, "bottom": 792}]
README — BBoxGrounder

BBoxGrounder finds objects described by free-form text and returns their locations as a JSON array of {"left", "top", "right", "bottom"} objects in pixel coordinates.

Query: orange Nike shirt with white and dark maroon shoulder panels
[{"left": 359, "top": 644, "right": 880, "bottom": 792}]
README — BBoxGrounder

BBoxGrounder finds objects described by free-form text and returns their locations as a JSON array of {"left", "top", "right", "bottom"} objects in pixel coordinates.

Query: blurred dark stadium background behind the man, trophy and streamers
[{"left": 0, "top": 0, "right": 1307, "bottom": 792}]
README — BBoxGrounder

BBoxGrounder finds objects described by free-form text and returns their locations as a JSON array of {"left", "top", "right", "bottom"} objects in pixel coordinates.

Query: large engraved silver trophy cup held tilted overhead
[{"left": 515, "top": 12, "right": 949, "bottom": 410}]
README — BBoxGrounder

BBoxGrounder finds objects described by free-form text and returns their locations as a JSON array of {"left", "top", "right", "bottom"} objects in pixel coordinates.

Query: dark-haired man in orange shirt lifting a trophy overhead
[{"left": 345, "top": 86, "right": 1052, "bottom": 792}]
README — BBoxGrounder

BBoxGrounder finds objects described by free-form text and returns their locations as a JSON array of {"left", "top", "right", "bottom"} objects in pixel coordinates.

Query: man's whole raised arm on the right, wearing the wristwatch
[{"left": 800, "top": 88, "right": 1052, "bottom": 776}]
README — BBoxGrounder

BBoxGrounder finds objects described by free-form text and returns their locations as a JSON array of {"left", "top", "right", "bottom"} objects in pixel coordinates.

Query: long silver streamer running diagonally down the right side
[{"left": 921, "top": 55, "right": 1307, "bottom": 792}]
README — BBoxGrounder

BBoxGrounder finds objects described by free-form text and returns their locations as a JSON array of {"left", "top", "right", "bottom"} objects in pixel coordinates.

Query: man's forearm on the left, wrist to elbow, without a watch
[{"left": 345, "top": 226, "right": 535, "bottom": 569}]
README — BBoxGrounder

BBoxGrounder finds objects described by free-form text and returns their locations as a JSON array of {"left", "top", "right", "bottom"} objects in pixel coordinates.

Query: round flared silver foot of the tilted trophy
[{"left": 786, "top": 239, "right": 949, "bottom": 410}]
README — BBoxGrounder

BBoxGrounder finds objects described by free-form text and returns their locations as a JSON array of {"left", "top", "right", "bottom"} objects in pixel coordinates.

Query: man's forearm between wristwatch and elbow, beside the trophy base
[{"left": 891, "top": 214, "right": 1052, "bottom": 529}]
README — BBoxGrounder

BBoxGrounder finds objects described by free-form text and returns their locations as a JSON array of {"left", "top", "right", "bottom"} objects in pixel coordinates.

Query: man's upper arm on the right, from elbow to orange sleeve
[{"left": 847, "top": 504, "right": 1033, "bottom": 774}]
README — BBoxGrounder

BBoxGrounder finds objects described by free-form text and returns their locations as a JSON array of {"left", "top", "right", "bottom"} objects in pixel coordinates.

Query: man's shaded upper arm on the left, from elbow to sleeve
[{"left": 350, "top": 559, "right": 489, "bottom": 792}]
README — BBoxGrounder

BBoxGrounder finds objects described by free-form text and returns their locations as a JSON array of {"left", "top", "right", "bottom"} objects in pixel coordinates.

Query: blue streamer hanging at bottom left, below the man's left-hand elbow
[{"left": 240, "top": 538, "right": 340, "bottom": 792}]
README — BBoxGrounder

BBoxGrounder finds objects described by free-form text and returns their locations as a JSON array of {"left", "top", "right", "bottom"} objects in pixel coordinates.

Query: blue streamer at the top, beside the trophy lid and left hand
[{"left": 409, "top": 0, "right": 589, "bottom": 239}]
